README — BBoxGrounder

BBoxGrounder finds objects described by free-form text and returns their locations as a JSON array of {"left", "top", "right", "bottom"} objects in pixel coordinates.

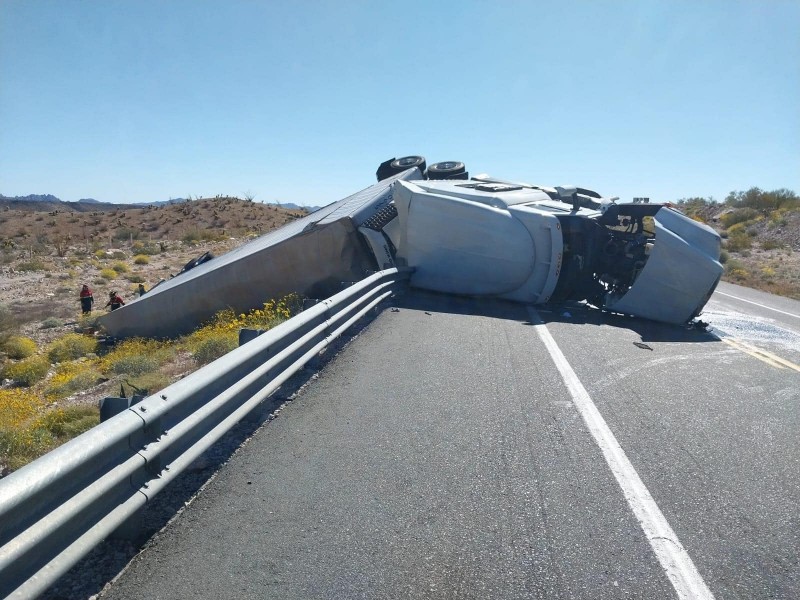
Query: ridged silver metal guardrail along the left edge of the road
[{"left": 0, "top": 269, "right": 408, "bottom": 598}]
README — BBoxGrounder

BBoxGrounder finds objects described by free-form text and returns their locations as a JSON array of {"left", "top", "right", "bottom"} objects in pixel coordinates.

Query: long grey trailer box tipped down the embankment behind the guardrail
[{"left": 99, "top": 168, "right": 422, "bottom": 338}]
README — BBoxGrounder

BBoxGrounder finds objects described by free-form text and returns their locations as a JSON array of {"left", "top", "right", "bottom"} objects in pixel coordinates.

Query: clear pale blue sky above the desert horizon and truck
[{"left": 0, "top": 0, "right": 800, "bottom": 205}]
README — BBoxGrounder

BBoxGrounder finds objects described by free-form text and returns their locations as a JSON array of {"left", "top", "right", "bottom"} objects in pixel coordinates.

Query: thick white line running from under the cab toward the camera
[{"left": 528, "top": 307, "right": 714, "bottom": 600}]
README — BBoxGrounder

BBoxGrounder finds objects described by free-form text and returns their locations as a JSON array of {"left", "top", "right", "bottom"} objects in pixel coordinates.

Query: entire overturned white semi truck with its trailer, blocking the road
[{"left": 100, "top": 156, "right": 723, "bottom": 337}]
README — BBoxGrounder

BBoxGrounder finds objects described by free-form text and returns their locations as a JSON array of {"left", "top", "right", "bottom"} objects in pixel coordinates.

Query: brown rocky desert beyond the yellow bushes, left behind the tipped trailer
[{"left": 0, "top": 197, "right": 305, "bottom": 342}]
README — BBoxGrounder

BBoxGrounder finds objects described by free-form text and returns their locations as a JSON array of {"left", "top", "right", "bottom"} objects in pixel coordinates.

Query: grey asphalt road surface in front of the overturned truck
[{"left": 103, "top": 285, "right": 800, "bottom": 599}]
